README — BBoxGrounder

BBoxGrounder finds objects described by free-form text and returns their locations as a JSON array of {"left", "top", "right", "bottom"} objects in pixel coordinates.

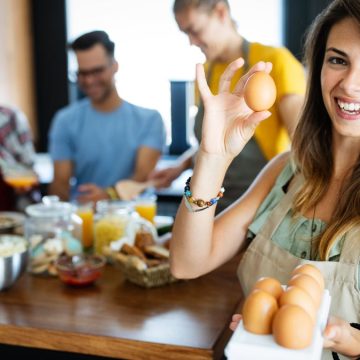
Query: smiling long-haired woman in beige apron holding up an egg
[{"left": 171, "top": 0, "right": 360, "bottom": 359}]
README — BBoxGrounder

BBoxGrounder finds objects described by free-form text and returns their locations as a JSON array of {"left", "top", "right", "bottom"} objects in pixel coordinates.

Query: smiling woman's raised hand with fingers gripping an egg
[{"left": 196, "top": 58, "right": 272, "bottom": 158}]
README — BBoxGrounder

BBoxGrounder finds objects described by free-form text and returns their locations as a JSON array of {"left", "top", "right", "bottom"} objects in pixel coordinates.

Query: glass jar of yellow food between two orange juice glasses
[{"left": 94, "top": 200, "right": 133, "bottom": 255}]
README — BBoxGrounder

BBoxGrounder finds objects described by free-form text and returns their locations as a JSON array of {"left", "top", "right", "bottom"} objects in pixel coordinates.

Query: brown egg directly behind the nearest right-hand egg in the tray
[{"left": 278, "top": 286, "right": 317, "bottom": 324}]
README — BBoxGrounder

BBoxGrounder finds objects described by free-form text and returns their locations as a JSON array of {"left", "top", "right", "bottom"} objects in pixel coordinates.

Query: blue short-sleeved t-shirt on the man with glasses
[{"left": 49, "top": 98, "right": 166, "bottom": 197}]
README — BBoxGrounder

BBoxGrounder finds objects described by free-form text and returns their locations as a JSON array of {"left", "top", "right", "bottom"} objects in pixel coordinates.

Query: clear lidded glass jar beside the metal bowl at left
[{"left": 24, "top": 196, "right": 82, "bottom": 275}]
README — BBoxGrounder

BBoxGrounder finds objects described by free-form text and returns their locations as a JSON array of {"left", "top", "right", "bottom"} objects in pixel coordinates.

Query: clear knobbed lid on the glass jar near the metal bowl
[{"left": 25, "top": 196, "right": 75, "bottom": 218}]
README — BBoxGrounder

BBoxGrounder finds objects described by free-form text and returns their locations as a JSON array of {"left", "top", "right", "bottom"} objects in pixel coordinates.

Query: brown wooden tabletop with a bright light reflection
[{"left": 0, "top": 258, "right": 242, "bottom": 360}]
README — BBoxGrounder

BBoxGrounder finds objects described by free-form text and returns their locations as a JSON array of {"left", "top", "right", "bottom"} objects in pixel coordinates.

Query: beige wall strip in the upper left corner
[{"left": 0, "top": 0, "right": 37, "bottom": 142}]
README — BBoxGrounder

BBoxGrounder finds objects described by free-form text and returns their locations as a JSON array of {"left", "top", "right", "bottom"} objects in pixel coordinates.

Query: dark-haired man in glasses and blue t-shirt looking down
[{"left": 49, "top": 31, "right": 165, "bottom": 202}]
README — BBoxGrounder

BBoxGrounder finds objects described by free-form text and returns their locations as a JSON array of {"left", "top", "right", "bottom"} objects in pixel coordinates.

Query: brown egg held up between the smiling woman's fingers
[{"left": 244, "top": 71, "right": 276, "bottom": 111}]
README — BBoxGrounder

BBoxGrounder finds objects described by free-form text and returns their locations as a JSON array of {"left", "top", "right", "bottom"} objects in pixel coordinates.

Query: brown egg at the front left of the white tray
[{"left": 242, "top": 289, "right": 278, "bottom": 334}]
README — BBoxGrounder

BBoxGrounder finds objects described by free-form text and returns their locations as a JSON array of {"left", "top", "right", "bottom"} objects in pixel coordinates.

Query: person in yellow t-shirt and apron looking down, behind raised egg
[{"left": 151, "top": 0, "right": 305, "bottom": 211}]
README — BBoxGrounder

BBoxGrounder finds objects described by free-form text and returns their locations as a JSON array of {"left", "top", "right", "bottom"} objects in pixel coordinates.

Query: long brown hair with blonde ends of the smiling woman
[{"left": 292, "top": 0, "right": 360, "bottom": 260}]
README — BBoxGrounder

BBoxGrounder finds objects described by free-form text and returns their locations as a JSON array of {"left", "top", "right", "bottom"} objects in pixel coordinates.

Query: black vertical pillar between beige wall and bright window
[{"left": 30, "top": 0, "right": 69, "bottom": 152}]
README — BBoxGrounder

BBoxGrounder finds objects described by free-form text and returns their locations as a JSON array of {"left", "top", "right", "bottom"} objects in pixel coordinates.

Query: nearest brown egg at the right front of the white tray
[{"left": 272, "top": 305, "right": 314, "bottom": 349}]
